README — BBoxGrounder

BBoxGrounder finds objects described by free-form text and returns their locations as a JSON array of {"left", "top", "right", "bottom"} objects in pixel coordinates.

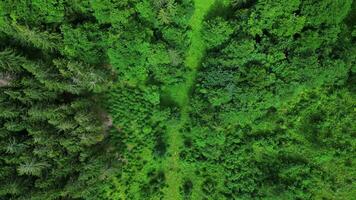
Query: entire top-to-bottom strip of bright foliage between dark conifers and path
[{"left": 102, "top": 0, "right": 197, "bottom": 199}]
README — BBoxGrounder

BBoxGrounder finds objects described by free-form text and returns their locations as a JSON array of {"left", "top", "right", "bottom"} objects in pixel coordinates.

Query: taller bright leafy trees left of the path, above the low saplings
[{"left": 97, "top": 0, "right": 191, "bottom": 85}]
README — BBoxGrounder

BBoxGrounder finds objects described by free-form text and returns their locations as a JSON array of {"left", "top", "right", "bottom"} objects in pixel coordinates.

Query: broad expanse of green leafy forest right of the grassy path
[{"left": 181, "top": 0, "right": 356, "bottom": 199}]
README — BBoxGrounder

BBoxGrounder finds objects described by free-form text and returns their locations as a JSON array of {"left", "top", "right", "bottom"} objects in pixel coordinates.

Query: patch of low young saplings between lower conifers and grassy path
[{"left": 110, "top": 85, "right": 170, "bottom": 199}]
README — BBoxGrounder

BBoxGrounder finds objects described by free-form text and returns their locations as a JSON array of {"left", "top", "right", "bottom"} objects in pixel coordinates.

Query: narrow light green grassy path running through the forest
[{"left": 163, "top": 0, "right": 215, "bottom": 200}]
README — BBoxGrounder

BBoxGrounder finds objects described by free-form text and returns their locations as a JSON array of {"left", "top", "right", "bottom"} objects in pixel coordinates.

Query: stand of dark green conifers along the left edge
[{"left": 0, "top": 1, "right": 120, "bottom": 200}]
